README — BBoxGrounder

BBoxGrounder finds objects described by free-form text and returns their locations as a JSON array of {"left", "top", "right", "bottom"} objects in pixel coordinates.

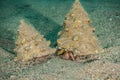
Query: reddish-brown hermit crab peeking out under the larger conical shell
[{"left": 56, "top": 47, "right": 100, "bottom": 62}]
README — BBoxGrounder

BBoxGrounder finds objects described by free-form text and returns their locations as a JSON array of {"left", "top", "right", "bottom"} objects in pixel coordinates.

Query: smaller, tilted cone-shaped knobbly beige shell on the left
[{"left": 14, "top": 20, "right": 55, "bottom": 61}]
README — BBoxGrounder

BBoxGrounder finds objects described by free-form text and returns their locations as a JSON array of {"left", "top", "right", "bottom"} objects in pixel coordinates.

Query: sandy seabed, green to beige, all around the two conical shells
[{"left": 0, "top": 0, "right": 120, "bottom": 80}]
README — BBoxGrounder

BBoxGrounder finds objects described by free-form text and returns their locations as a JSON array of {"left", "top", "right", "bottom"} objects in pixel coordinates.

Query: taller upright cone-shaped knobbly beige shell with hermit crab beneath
[{"left": 57, "top": 0, "right": 103, "bottom": 56}]
